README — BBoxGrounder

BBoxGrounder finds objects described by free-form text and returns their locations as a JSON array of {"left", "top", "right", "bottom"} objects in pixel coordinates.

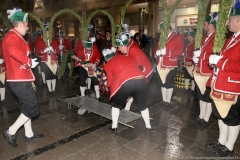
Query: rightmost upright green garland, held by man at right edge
[{"left": 213, "top": 0, "right": 232, "bottom": 54}]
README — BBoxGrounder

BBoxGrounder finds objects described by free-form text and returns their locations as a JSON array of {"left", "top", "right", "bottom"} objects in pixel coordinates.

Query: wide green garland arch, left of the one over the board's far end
[{"left": 49, "top": 9, "right": 85, "bottom": 43}]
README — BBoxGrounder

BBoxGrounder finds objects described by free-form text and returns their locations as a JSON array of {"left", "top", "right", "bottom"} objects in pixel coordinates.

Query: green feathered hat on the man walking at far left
[{"left": 7, "top": 7, "right": 28, "bottom": 22}]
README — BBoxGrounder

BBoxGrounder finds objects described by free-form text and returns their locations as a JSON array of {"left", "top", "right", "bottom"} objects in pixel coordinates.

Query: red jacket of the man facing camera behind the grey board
[{"left": 75, "top": 40, "right": 101, "bottom": 66}]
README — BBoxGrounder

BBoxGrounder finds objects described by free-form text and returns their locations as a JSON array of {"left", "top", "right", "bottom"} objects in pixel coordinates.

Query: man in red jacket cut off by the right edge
[{"left": 206, "top": 2, "right": 240, "bottom": 157}]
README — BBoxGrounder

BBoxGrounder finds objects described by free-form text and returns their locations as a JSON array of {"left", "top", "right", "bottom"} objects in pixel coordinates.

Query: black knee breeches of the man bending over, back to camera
[{"left": 111, "top": 79, "right": 147, "bottom": 111}]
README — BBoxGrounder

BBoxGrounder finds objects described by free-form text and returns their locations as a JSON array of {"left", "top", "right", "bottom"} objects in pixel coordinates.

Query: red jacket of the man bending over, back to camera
[{"left": 104, "top": 55, "right": 144, "bottom": 99}]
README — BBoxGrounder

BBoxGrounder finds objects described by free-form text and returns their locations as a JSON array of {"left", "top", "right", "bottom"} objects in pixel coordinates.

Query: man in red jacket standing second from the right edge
[{"left": 191, "top": 14, "right": 217, "bottom": 127}]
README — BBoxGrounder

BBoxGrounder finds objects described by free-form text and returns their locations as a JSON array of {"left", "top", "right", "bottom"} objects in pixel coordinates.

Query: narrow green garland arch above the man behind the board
[{"left": 84, "top": 9, "right": 115, "bottom": 46}]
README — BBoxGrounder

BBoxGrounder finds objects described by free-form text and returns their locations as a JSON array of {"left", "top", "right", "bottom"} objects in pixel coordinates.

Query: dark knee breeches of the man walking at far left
[{"left": 9, "top": 82, "right": 39, "bottom": 119}]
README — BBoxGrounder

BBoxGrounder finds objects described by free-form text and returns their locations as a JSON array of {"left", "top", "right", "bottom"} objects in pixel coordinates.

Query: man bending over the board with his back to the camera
[{"left": 103, "top": 48, "right": 151, "bottom": 134}]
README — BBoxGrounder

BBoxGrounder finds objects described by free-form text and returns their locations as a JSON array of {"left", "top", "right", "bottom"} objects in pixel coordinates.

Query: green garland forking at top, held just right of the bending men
[{"left": 158, "top": 0, "right": 182, "bottom": 49}]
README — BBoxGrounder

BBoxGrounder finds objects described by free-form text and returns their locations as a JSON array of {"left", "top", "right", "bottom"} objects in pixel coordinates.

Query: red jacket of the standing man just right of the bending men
[{"left": 154, "top": 32, "right": 184, "bottom": 68}]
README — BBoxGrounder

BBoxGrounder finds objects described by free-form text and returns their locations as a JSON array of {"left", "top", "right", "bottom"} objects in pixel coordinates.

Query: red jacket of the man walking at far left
[{"left": 2, "top": 29, "right": 35, "bottom": 82}]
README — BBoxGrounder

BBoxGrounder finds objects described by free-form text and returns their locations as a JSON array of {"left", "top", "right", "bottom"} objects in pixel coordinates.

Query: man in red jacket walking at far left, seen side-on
[{"left": 2, "top": 8, "right": 44, "bottom": 147}]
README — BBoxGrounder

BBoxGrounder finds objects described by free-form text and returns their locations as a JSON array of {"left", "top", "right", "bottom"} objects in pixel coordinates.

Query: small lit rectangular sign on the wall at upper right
[{"left": 176, "top": 15, "right": 198, "bottom": 27}]
